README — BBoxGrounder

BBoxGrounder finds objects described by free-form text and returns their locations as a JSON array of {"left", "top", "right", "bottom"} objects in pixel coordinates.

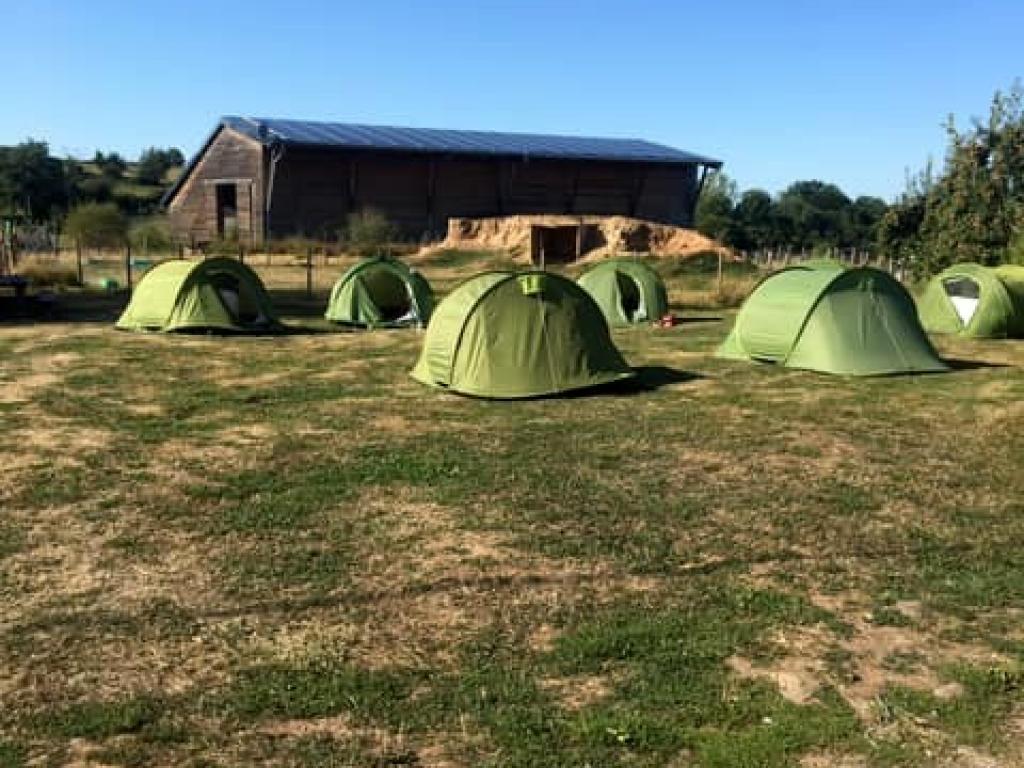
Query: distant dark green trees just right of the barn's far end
[{"left": 696, "top": 172, "right": 888, "bottom": 251}]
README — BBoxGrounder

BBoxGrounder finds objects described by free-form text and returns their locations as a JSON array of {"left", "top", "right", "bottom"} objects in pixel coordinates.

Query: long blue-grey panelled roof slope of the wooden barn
[{"left": 223, "top": 117, "right": 721, "bottom": 167}]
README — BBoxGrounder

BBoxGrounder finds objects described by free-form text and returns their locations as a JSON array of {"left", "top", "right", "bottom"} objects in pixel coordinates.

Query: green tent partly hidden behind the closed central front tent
[{"left": 577, "top": 259, "right": 669, "bottom": 327}]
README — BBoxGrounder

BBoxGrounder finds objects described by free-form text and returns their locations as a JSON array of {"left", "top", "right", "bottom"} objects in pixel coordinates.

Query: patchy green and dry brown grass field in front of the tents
[{"left": 0, "top": 264, "right": 1024, "bottom": 768}]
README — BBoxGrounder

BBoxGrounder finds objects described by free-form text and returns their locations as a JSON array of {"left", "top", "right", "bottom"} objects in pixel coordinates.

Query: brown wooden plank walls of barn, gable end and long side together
[{"left": 169, "top": 137, "right": 697, "bottom": 243}]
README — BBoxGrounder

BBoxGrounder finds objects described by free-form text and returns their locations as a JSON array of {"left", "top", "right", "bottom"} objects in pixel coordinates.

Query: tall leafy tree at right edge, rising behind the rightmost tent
[{"left": 879, "top": 82, "right": 1024, "bottom": 278}]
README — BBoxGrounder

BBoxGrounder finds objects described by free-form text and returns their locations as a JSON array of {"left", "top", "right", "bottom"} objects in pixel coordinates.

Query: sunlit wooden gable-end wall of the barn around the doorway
[{"left": 168, "top": 128, "right": 263, "bottom": 243}]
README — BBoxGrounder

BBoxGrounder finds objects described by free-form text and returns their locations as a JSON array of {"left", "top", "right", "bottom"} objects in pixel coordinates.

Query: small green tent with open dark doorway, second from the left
[{"left": 324, "top": 258, "right": 434, "bottom": 328}]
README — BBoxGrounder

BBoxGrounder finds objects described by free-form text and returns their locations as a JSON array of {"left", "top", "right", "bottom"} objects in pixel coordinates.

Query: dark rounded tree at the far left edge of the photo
[{"left": 0, "top": 139, "right": 69, "bottom": 221}]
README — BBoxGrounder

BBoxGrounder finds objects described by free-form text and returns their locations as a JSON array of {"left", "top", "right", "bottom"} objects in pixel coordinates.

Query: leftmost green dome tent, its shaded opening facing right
[{"left": 117, "top": 258, "right": 281, "bottom": 333}]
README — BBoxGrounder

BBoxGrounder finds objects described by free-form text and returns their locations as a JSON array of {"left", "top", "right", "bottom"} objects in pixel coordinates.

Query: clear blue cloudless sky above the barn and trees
[{"left": 0, "top": 0, "right": 1024, "bottom": 199}]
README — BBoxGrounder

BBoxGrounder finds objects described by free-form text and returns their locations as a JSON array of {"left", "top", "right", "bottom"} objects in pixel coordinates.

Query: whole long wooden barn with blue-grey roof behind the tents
[{"left": 164, "top": 117, "right": 721, "bottom": 245}]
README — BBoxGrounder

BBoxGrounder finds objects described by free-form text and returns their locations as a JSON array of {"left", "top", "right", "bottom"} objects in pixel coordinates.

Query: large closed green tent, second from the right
[{"left": 718, "top": 265, "right": 947, "bottom": 376}]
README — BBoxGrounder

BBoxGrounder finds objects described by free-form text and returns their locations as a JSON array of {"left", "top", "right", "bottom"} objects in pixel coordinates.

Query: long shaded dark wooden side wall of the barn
[{"left": 270, "top": 147, "right": 696, "bottom": 238}]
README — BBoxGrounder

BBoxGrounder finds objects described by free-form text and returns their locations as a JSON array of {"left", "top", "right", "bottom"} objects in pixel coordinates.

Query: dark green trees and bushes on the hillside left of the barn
[{"left": 0, "top": 139, "right": 184, "bottom": 221}]
